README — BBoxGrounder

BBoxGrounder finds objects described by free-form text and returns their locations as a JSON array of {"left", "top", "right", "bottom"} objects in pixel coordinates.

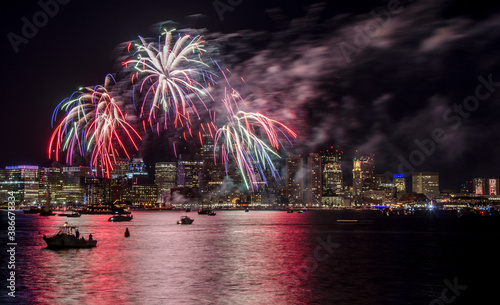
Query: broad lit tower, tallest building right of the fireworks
[{"left": 320, "top": 146, "right": 344, "bottom": 194}]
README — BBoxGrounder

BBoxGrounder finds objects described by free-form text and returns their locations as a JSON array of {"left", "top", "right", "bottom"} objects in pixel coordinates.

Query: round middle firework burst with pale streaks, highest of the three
[{"left": 123, "top": 31, "right": 214, "bottom": 132}]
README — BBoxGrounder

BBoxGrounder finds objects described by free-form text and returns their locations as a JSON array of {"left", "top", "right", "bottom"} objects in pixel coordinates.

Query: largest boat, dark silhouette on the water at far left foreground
[{"left": 43, "top": 222, "right": 97, "bottom": 249}]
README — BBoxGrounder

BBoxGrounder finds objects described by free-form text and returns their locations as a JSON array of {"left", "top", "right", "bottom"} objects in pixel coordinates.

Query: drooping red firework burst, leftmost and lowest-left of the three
[{"left": 49, "top": 77, "right": 142, "bottom": 178}]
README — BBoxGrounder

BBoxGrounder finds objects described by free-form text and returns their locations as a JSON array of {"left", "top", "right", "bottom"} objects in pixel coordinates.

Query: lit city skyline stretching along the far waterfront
[{"left": 0, "top": 142, "right": 500, "bottom": 206}]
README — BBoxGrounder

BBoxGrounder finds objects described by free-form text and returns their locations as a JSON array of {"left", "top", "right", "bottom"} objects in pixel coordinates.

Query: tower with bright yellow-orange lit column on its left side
[{"left": 352, "top": 154, "right": 375, "bottom": 196}]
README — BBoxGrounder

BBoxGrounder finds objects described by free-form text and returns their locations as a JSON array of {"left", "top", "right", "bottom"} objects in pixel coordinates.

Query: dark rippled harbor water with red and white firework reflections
[{"left": 0, "top": 210, "right": 500, "bottom": 304}]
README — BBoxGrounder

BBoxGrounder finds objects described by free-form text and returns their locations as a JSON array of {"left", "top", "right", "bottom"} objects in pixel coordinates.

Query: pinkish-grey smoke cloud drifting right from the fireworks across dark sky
[{"left": 209, "top": 1, "right": 500, "bottom": 186}]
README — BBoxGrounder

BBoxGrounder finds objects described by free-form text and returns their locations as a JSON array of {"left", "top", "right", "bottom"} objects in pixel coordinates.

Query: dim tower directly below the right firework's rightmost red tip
[{"left": 285, "top": 155, "right": 304, "bottom": 203}]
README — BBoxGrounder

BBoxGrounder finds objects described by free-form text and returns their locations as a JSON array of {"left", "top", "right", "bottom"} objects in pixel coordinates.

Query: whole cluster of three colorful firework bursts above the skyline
[{"left": 49, "top": 31, "right": 297, "bottom": 190}]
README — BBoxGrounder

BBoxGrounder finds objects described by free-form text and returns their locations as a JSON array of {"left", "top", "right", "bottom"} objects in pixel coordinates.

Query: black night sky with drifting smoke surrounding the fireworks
[{"left": 0, "top": 0, "right": 500, "bottom": 189}]
